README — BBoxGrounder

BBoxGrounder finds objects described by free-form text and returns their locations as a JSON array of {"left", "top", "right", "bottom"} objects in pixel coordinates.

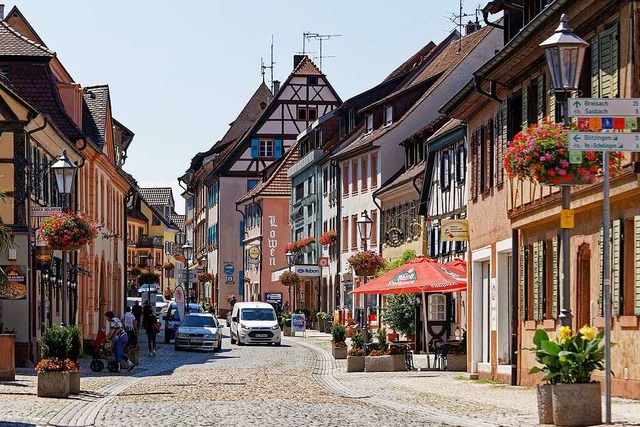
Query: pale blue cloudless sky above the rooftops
[{"left": 12, "top": 0, "right": 478, "bottom": 213}]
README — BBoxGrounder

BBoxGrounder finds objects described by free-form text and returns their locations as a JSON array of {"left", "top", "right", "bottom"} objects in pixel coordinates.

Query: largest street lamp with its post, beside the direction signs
[{"left": 540, "top": 14, "right": 584, "bottom": 326}]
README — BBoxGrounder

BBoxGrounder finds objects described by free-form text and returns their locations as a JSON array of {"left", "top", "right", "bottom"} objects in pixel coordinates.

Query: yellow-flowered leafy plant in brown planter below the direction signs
[{"left": 529, "top": 325, "right": 615, "bottom": 426}]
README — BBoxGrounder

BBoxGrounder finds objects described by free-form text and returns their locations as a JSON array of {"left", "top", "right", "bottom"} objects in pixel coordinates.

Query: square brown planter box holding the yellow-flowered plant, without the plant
[{"left": 551, "top": 383, "right": 602, "bottom": 426}]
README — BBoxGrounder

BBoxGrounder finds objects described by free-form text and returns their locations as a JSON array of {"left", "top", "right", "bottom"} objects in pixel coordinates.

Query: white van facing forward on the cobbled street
[{"left": 229, "top": 302, "right": 282, "bottom": 345}]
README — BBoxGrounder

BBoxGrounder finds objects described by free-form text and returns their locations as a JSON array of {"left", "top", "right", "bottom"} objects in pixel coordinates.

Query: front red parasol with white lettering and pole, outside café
[{"left": 351, "top": 256, "right": 467, "bottom": 368}]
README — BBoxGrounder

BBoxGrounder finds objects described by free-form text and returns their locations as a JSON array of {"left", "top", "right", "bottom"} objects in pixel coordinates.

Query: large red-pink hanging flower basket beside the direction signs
[{"left": 504, "top": 119, "right": 624, "bottom": 185}]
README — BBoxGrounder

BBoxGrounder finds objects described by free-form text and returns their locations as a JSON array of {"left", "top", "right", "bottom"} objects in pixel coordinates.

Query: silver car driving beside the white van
[{"left": 175, "top": 313, "right": 222, "bottom": 351}]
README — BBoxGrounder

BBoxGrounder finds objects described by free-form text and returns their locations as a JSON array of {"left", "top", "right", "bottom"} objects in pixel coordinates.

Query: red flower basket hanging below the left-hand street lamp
[{"left": 40, "top": 213, "right": 98, "bottom": 251}]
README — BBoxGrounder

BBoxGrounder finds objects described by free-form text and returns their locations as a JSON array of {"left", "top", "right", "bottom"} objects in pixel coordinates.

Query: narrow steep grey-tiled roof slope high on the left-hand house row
[{"left": 82, "top": 85, "right": 110, "bottom": 151}]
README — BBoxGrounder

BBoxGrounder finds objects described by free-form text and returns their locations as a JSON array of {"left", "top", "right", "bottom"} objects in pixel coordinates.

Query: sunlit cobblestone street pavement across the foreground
[{"left": 0, "top": 330, "right": 640, "bottom": 426}]
